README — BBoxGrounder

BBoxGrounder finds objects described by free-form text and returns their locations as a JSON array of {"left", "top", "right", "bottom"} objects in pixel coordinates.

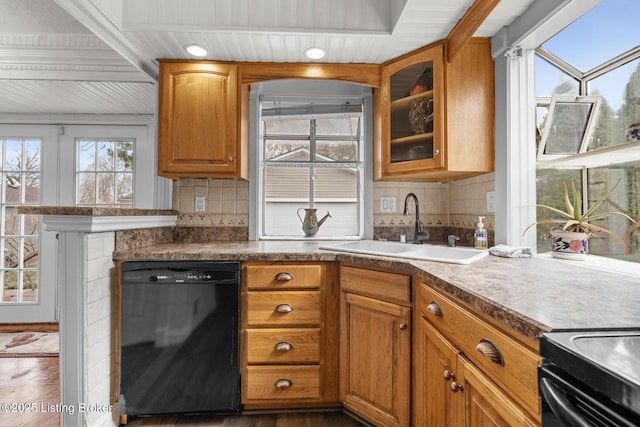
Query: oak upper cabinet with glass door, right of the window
[{"left": 374, "top": 39, "right": 494, "bottom": 181}]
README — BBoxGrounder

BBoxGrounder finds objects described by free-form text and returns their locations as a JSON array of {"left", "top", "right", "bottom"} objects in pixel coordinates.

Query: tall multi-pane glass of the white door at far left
[{"left": 0, "top": 138, "right": 42, "bottom": 304}]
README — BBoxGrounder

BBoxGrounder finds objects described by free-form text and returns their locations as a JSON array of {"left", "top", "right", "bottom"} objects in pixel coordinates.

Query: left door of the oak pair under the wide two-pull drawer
[{"left": 413, "top": 316, "right": 460, "bottom": 426}]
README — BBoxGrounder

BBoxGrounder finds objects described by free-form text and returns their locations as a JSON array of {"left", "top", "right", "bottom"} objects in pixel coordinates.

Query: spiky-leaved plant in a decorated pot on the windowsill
[{"left": 523, "top": 180, "right": 636, "bottom": 260}]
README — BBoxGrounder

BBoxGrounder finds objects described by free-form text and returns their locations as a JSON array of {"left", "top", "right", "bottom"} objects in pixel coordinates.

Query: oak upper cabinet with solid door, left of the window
[{"left": 158, "top": 60, "right": 248, "bottom": 179}]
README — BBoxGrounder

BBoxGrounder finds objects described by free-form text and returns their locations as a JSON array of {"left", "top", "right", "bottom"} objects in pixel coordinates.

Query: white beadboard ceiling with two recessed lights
[{"left": 0, "top": 0, "right": 534, "bottom": 117}]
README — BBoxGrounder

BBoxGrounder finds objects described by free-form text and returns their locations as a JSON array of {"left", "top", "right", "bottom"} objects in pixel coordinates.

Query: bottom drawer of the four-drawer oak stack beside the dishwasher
[{"left": 242, "top": 365, "right": 322, "bottom": 400}]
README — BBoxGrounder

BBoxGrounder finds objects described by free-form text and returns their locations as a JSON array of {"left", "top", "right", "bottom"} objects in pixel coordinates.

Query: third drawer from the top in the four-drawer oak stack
[{"left": 247, "top": 328, "right": 320, "bottom": 364}]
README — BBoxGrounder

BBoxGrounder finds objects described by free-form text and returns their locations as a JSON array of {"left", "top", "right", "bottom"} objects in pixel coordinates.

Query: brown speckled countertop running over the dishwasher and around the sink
[{"left": 114, "top": 241, "right": 640, "bottom": 339}]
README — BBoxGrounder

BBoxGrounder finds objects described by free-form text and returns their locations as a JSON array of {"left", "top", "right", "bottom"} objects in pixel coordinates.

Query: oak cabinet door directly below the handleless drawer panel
[{"left": 340, "top": 292, "right": 411, "bottom": 426}]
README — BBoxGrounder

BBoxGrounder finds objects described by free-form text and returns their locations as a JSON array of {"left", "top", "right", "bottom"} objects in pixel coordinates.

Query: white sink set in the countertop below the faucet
[{"left": 320, "top": 240, "right": 489, "bottom": 264}]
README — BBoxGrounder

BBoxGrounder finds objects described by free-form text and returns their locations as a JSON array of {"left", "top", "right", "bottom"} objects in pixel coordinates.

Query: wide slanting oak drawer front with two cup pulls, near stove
[{"left": 417, "top": 283, "right": 540, "bottom": 420}]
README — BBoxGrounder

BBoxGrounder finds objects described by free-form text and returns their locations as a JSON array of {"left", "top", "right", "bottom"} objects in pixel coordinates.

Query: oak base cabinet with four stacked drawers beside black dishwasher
[{"left": 241, "top": 262, "right": 340, "bottom": 409}]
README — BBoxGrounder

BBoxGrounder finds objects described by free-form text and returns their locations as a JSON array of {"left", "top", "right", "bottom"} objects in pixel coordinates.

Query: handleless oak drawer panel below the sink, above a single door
[{"left": 340, "top": 266, "right": 411, "bottom": 304}]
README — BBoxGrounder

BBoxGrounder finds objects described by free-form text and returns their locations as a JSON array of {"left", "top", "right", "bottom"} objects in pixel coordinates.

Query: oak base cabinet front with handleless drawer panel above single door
[{"left": 340, "top": 266, "right": 411, "bottom": 427}]
